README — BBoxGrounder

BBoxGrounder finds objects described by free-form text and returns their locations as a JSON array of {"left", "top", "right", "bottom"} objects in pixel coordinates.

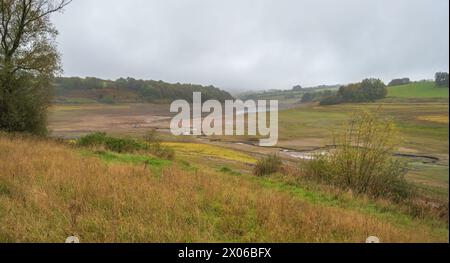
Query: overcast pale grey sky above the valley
[{"left": 53, "top": 0, "right": 449, "bottom": 90}]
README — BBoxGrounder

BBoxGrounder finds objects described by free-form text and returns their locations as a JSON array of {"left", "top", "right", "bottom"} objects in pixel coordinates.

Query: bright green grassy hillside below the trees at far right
[{"left": 388, "top": 81, "right": 449, "bottom": 99}]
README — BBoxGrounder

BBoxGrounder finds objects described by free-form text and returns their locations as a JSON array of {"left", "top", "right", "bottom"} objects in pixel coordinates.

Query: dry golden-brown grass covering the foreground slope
[{"left": 0, "top": 135, "right": 447, "bottom": 242}]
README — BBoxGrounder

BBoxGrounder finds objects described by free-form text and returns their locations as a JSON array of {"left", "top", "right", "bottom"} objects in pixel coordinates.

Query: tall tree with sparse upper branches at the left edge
[{"left": 0, "top": 0, "right": 71, "bottom": 135}]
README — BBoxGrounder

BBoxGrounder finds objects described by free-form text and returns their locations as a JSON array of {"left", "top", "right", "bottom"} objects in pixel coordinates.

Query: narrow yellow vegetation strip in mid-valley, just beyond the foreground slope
[{"left": 164, "top": 142, "right": 257, "bottom": 163}]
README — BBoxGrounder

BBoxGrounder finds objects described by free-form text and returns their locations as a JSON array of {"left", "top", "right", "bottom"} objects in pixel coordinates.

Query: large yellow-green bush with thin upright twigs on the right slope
[{"left": 304, "top": 112, "right": 411, "bottom": 200}]
